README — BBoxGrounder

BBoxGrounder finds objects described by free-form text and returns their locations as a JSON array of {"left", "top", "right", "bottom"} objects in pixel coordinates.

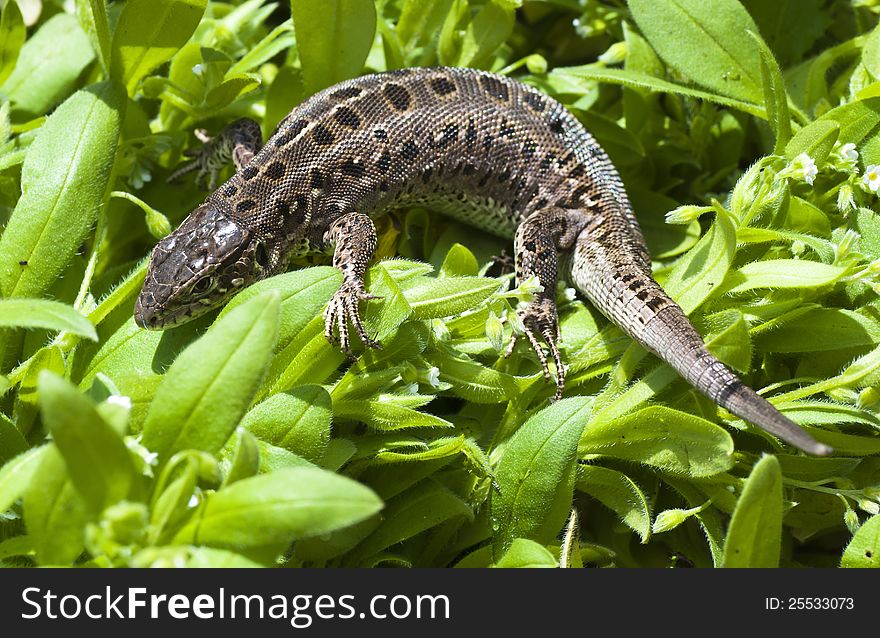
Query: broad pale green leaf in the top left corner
[{"left": 0, "top": 13, "right": 94, "bottom": 116}]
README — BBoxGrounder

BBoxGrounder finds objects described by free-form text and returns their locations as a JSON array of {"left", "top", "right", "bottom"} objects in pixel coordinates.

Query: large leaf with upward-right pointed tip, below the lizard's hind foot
[{"left": 490, "top": 397, "right": 592, "bottom": 557}]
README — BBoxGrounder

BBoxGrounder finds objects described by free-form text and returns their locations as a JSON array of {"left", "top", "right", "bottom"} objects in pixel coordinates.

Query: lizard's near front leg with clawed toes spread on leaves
[{"left": 324, "top": 213, "right": 381, "bottom": 358}]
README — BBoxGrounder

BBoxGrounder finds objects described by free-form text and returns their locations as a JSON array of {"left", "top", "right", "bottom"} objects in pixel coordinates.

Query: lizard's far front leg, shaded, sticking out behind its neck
[{"left": 168, "top": 118, "right": 263, "bottom": 190}]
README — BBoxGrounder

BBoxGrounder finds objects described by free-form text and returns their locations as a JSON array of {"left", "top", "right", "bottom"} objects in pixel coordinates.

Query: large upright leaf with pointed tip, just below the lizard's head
[{"left": 143, "top": 291, "right": 280, "bottom": 463}]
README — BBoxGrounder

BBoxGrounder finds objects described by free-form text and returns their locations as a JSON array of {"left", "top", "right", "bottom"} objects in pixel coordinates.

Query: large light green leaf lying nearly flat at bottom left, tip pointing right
[{"left": 174, "top": 468, "right": 382, "bottom": 548}]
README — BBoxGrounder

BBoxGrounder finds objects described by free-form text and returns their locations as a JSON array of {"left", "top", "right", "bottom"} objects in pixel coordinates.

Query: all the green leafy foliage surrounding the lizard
[{"left": 0, "top": 0, "right": 880, "bottom": 567}]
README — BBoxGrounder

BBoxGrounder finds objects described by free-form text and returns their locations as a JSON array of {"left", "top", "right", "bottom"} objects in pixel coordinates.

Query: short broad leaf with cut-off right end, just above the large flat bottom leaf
[{"left": 241, "top": 385, "right": 332, "bottom": 463}]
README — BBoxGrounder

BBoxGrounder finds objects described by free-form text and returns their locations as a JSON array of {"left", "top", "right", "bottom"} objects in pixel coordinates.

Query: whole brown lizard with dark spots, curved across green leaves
[{"left": 135, "top": 67, "right": 832, "bottom": 455}]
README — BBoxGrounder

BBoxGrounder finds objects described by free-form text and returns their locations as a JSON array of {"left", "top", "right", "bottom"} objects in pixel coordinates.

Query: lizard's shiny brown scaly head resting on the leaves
[{"left": 134, "top": 202, "right": 279, "bottom": 330}]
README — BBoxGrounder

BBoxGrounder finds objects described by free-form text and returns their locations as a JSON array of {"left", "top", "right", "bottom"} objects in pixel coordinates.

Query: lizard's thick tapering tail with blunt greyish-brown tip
[{"left": 571, "top": 234, "right": 833, "bottom": 456}]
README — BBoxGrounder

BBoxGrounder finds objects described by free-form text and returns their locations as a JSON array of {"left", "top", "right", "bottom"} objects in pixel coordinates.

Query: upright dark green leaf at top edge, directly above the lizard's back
[{"left": 290, "top": 0, "right": 376, "bottom": 95}]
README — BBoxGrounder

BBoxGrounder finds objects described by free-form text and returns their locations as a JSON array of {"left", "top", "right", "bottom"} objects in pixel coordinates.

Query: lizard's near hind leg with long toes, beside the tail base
[{"left": 505, "top": 209, "right": 589, "bottom": 400}]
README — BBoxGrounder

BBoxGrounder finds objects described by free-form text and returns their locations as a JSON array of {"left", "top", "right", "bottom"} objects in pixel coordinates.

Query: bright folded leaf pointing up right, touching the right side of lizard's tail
[{"left": 663, "top": 213, "right": 736, "bottom": 314}]
